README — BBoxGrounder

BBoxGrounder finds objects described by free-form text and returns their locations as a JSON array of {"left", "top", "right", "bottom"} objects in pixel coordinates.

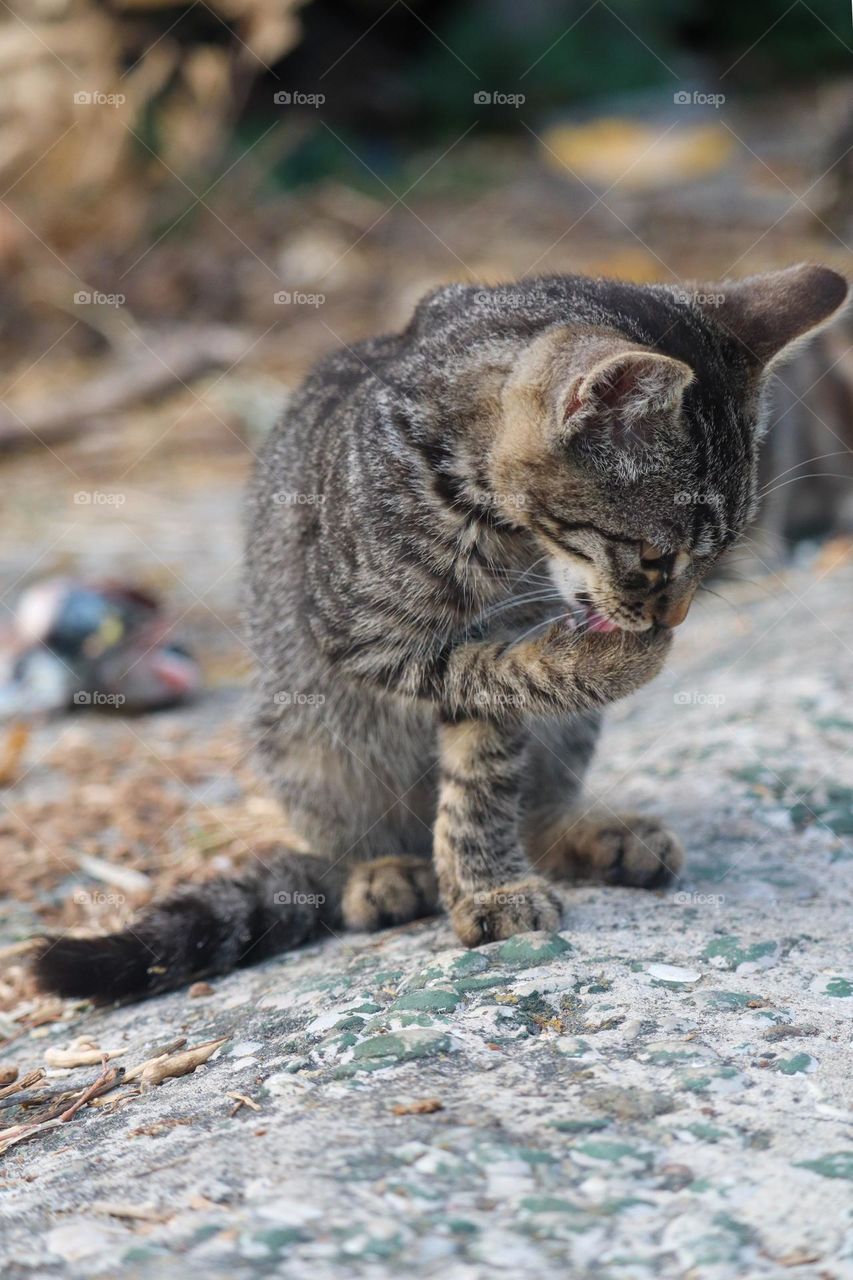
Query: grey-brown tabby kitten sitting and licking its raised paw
[{"left": 37, "top": 265, "right": 847, "bottom": 997}]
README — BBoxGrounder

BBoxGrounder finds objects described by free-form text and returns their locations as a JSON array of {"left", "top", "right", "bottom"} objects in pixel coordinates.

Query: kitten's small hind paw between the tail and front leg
[{"left": 342, "top": 858, "right": 439, "bottom": 929}]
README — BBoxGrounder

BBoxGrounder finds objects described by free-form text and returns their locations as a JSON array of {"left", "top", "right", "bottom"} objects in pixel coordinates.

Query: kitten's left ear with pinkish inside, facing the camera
[{"left": 562, "top": 348, "right": 693, "bottom": 447}]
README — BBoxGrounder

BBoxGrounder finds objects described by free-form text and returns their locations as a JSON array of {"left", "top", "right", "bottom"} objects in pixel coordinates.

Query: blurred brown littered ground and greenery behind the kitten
[{"left": 0, "top": 0, "right": 853, "bottom": 998}]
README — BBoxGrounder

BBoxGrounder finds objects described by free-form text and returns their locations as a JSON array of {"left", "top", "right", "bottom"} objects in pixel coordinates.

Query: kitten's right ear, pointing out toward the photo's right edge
[{"left": 699, "top": 262, "right": 848, "bottom": 366}]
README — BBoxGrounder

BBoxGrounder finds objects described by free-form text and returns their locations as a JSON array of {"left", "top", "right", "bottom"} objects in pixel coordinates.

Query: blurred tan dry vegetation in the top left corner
[{"left": 0, "top": 0, "right": 306, "bottom": 265}]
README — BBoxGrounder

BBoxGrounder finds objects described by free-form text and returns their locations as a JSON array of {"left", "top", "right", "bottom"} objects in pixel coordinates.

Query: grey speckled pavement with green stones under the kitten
[{"left": 0, "top": 557, "right": 853, "bottom": 1280}]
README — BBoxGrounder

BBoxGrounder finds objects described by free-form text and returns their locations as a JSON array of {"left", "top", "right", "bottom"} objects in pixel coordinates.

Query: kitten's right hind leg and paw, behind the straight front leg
[{"left": 524, "top": 716, "right": 684, "bottom": 888}]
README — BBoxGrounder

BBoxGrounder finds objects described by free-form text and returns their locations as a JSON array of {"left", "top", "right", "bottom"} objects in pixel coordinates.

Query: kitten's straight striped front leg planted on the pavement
[{"left": 434, "top": 719, "right": 561, "bottom": 946}]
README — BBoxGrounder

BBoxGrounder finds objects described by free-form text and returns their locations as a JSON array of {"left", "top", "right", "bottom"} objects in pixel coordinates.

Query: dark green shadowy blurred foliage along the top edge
[{"left": 266, "top": 0, "right": 853, "bottom": 189}]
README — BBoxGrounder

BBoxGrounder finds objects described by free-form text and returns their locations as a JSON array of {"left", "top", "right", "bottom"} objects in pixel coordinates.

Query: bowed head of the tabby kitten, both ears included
[{"left": 489, "top": 265, "right": 847, "bottom": 631}]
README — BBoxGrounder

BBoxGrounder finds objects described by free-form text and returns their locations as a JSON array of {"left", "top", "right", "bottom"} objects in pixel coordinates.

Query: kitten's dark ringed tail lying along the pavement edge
[{"left": 33, "top": 850, "right": 341, "bottom": 1000}]
